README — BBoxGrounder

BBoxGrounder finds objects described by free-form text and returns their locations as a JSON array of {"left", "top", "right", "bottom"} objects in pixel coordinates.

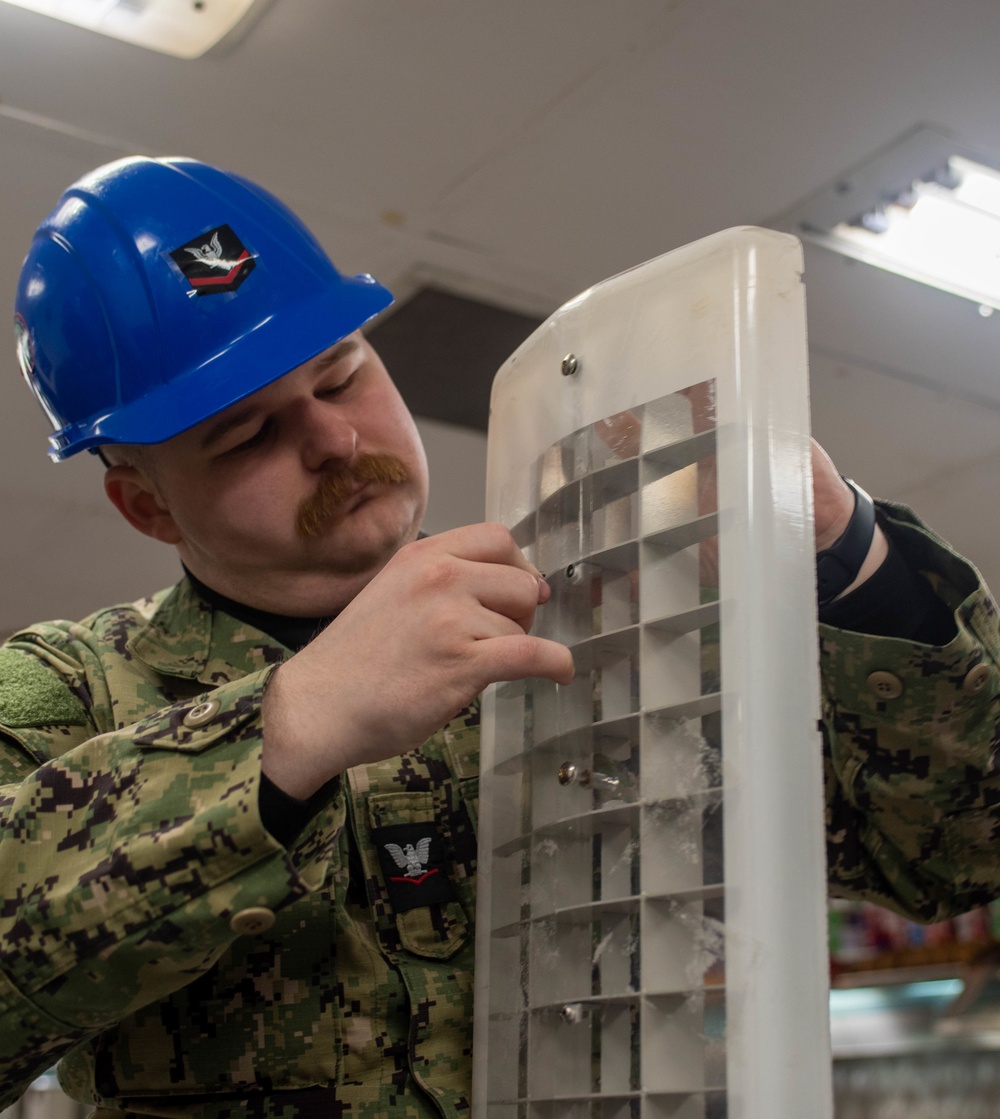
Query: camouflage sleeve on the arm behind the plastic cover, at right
[{"left": 820, "top": 504, "right": 1000, "bottom": 921}]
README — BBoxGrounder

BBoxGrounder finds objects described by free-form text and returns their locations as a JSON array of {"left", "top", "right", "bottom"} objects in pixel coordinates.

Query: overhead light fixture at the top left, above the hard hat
[{"left": 0, "top": 0, "right": 266, "bottom": 58}]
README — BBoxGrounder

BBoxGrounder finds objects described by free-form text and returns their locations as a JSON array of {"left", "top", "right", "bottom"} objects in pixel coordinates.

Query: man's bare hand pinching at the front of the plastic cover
[{"left": 262, "top": 525, "right": 574, "bottom": 800}]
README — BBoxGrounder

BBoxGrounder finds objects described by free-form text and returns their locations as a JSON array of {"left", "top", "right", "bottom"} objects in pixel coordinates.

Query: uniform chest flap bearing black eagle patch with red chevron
[{"left": 368, "top": 792, "right": 471, "bottom": 960}]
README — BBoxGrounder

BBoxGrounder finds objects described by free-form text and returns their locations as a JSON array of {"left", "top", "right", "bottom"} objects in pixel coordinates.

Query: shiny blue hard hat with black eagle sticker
[{"left": 15, "top": 157, "right": 393, "bottom": 461}]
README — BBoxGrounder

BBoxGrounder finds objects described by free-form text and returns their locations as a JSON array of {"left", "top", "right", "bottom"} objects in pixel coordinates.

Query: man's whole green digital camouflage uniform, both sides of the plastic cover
[{"left": 0, "top": 508, "right": 1000, "bottom": 1119}]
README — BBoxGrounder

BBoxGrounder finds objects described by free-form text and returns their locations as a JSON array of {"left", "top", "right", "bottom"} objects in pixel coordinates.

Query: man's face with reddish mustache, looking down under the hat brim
[{"left": 126, "top": 333, "right": 427, "bottom": 615}]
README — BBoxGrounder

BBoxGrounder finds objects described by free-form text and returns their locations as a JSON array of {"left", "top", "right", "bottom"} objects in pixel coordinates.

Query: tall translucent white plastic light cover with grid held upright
[{"left": 472, "top": 229, "right": 832, "bottom": 1119}]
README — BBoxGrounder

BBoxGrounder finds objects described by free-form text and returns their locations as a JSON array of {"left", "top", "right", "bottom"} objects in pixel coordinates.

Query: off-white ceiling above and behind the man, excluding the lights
[{"left": 0, "top": 0, "right": 1000, "bottom": 631}]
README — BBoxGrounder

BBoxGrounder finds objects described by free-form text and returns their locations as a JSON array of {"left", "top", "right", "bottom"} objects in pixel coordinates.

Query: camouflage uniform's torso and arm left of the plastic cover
[{"left": 0, "top": 581, "right": 479, "bottom": 1119}]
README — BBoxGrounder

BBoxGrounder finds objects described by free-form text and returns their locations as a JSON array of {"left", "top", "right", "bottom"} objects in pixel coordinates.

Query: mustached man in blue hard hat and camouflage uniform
[{"left": 0, "top": 159, "right": 996, "bottom": 1119}]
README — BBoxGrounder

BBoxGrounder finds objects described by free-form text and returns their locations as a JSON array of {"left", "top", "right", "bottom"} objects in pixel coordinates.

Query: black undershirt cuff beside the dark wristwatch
[{"left": 820, "top": 517, "right": 959, "bottom": 646}]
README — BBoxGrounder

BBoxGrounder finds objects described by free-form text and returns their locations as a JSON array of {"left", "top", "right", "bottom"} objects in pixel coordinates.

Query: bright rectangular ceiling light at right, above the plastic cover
[{"left": 774, "top": 128, "right": 1000, "bottom": 317}]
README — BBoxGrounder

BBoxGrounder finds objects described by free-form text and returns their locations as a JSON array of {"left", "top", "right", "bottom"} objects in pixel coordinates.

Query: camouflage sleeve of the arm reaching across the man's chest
[{"left": 0, "top": 635, "right": 345, "bottom": 1108}]
